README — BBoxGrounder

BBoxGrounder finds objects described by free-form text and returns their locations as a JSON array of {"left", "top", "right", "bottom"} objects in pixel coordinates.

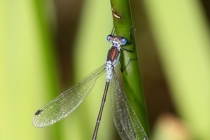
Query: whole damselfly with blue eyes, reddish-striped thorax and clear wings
[{"left": 33, "top": 34, "right": 148, "bottom": 140}]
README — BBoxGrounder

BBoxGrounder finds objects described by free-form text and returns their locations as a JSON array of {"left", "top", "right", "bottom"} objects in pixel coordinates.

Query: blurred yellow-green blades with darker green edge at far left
[{"left": 0, "top": 0, "right": 59, "bottom": 140}]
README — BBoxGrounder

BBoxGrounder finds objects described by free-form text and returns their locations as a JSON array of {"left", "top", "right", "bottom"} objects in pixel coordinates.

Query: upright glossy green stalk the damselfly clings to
[{"left": 111, "top": 0, "right": 149, "bottom": 134}]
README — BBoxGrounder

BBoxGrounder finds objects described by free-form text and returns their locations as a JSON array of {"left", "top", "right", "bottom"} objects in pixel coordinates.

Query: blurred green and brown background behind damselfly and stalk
[{"left": 0, "top": 0, "right": 210, "bottom": 140}]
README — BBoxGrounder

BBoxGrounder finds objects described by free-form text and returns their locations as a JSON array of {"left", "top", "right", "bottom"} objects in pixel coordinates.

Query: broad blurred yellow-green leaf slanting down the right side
[{"left": 144, "top": 0, "right": 210, "bottom": 140}]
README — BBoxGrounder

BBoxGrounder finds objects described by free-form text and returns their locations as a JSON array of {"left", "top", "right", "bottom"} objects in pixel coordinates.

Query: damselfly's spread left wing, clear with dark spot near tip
[{"left": 33, "top": 64, "right": 106, "bottom": 127}]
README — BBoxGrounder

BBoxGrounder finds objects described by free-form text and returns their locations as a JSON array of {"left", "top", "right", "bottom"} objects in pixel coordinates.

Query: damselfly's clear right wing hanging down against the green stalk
[{"left": 110, "top": 72, "right": 148, "bottom": 140}]
